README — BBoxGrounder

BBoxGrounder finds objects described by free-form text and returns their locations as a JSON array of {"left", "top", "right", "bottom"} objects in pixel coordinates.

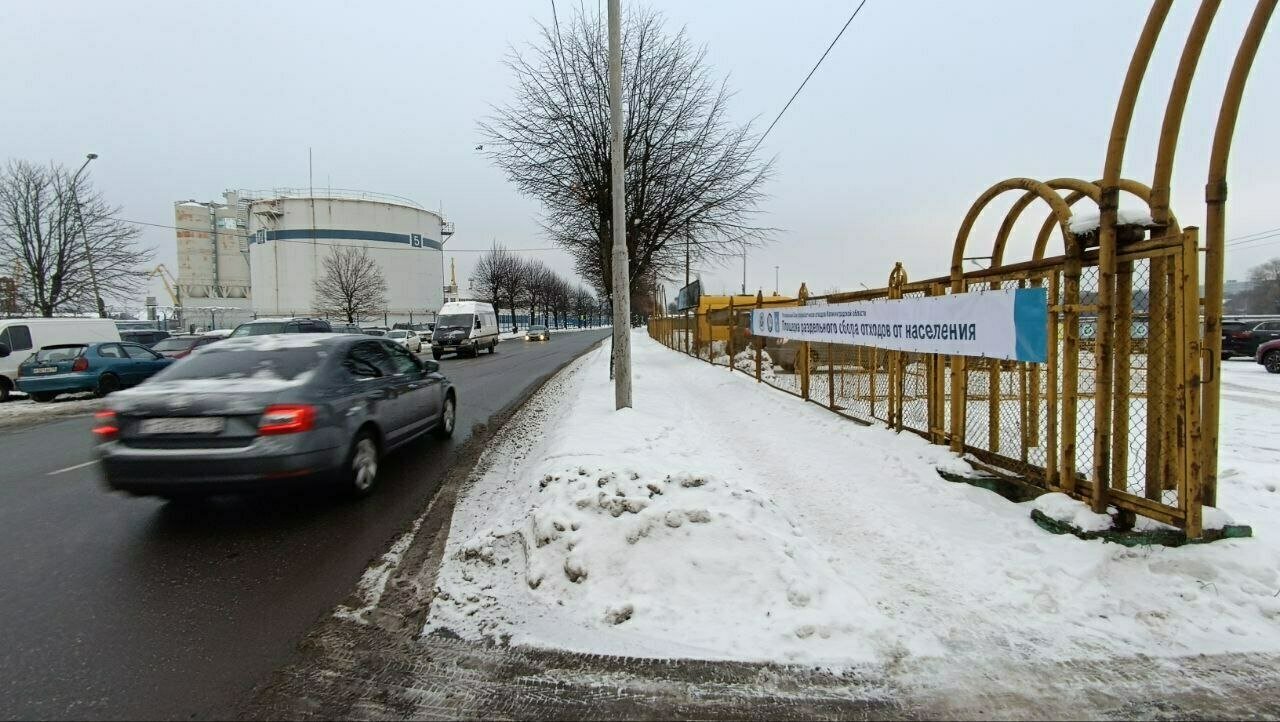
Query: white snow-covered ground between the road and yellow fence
[{"left": 425, "top": 332, "right": 1280, "bottom": 678}]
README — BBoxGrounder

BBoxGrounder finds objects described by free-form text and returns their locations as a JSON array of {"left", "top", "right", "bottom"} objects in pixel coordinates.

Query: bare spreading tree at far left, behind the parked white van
[{"left": 0, "top": 160, "right": 154, "bottom": 316}]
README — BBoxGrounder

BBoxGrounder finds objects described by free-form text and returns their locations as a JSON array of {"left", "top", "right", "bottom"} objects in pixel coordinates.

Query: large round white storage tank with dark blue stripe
[{"left": 248, "top": 189, "right": 452, "bottom": 321}]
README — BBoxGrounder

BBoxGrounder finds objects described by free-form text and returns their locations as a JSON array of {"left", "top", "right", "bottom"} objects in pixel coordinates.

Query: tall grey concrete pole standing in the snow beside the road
[{"left": 609, "top": 0, "right": 631, "bottom": 408}]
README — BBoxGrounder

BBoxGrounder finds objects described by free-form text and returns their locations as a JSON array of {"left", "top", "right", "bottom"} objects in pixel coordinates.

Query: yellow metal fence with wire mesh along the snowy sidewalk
[{"left": 649, "top": 228, "right": 1204, "bottom": 535}]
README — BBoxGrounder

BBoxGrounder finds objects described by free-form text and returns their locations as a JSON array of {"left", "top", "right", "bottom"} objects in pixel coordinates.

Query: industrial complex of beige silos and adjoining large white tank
[{"left": 174, "top": 188, "right": 453, "bottom": 328}]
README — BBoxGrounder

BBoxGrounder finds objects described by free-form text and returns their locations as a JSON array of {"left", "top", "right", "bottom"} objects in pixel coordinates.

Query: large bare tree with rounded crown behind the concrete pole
[{"left": 480, "top": 8, "right": 772, "bottom": 297}]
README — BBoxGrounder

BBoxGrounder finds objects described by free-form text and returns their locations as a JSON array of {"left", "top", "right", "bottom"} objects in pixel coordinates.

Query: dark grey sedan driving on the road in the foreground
[{"left": 93, "top": 334, "right": 457, "bottom": 498}]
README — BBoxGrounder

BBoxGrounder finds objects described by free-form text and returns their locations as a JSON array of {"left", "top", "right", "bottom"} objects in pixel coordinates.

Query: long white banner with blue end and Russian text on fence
[{"left": 751, "top": 288, "right": 1048, "bottom": 364}]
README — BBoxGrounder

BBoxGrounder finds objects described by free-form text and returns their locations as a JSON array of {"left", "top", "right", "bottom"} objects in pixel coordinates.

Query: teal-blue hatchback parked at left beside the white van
[{"left": 18, "top": 342, "right": 174, "bottom": 402}]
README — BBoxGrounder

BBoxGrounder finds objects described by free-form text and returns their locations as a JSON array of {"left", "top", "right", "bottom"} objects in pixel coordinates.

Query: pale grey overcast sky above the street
[{"left": 0, "top": 0, "right": 1280, "bottom": 304}]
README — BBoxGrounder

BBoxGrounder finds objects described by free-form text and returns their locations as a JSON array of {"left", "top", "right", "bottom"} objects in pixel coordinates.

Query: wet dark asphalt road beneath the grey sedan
[{"left": 0, "top": 330, "right": 607, "bottom": 719}]
